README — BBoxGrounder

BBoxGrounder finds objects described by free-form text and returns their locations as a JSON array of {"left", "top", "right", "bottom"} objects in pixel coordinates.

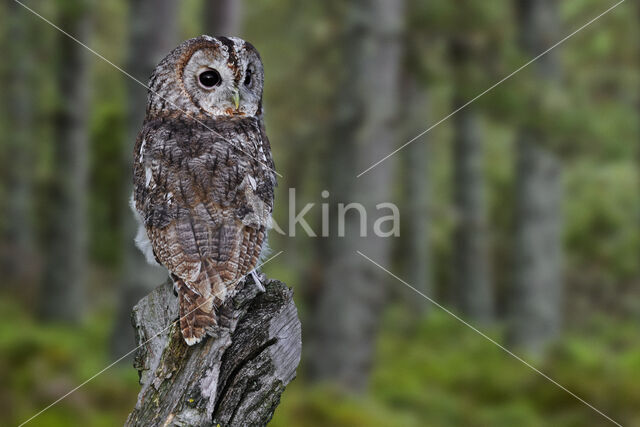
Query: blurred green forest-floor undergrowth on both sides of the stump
[{"left": 0, "top": 298, "right": 640, "bottom": 427}]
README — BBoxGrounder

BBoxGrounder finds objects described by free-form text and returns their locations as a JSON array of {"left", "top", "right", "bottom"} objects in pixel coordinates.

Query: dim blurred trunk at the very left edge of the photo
[{"left": 1, "top": 2, "right": 35, "bottom": 284}]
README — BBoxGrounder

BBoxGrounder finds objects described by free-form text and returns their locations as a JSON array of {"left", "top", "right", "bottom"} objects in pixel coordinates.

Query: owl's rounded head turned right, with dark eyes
[{"left": 148, "top": 36, "right": 264, "bottom": 117}]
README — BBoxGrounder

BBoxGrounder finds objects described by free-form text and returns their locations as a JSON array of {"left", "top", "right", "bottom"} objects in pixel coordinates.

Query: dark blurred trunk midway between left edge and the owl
[{"left": 40, "top": 0, "right": 91, "bottom": 322}]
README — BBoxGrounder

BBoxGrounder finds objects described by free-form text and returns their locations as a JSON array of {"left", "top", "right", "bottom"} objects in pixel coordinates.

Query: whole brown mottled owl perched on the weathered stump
[{"left": 132, "top": 36, "right": 276, "bottom": 345}]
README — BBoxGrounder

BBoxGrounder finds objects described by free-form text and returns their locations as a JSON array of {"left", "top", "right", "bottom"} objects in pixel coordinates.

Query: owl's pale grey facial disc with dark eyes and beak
[{"left": 182, "top": 39, "right": 262, "bottom": 117}]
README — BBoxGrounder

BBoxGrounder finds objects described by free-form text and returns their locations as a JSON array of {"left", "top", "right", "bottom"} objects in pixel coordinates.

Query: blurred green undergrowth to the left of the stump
[{"left": 0, "top": 295, "right": 138, "bottom": 426}]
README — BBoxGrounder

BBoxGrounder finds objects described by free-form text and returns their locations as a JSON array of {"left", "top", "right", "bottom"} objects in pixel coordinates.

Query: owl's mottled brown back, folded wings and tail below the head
[{"left": 134, "top": 117, "right": 276, "bottom": 343}]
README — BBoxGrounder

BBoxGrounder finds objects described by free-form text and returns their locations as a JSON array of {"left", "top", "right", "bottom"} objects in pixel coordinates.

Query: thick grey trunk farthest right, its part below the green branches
[{"left": 510, "top": 136, "right": 562, "bottom": 354}]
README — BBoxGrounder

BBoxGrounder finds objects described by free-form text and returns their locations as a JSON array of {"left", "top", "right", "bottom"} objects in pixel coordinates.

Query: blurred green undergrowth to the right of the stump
[{"left": 272, "top": 310, "right": 640, "bottom": 427}]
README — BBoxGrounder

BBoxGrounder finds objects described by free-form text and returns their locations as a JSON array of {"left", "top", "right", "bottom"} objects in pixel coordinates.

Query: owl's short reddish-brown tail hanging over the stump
[{"left": 174, "top": 277, "right": 218, "bottom": 345}]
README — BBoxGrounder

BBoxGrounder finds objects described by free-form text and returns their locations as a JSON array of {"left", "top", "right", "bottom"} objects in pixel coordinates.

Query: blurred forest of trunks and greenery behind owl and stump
[{"left": 0, "top": 0, "right": 640, "bottom": 426}]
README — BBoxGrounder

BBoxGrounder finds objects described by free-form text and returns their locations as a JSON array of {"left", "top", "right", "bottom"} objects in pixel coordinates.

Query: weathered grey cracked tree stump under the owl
[{"left": 125, "top": 278, "right": 302, "bottom": 427}]
